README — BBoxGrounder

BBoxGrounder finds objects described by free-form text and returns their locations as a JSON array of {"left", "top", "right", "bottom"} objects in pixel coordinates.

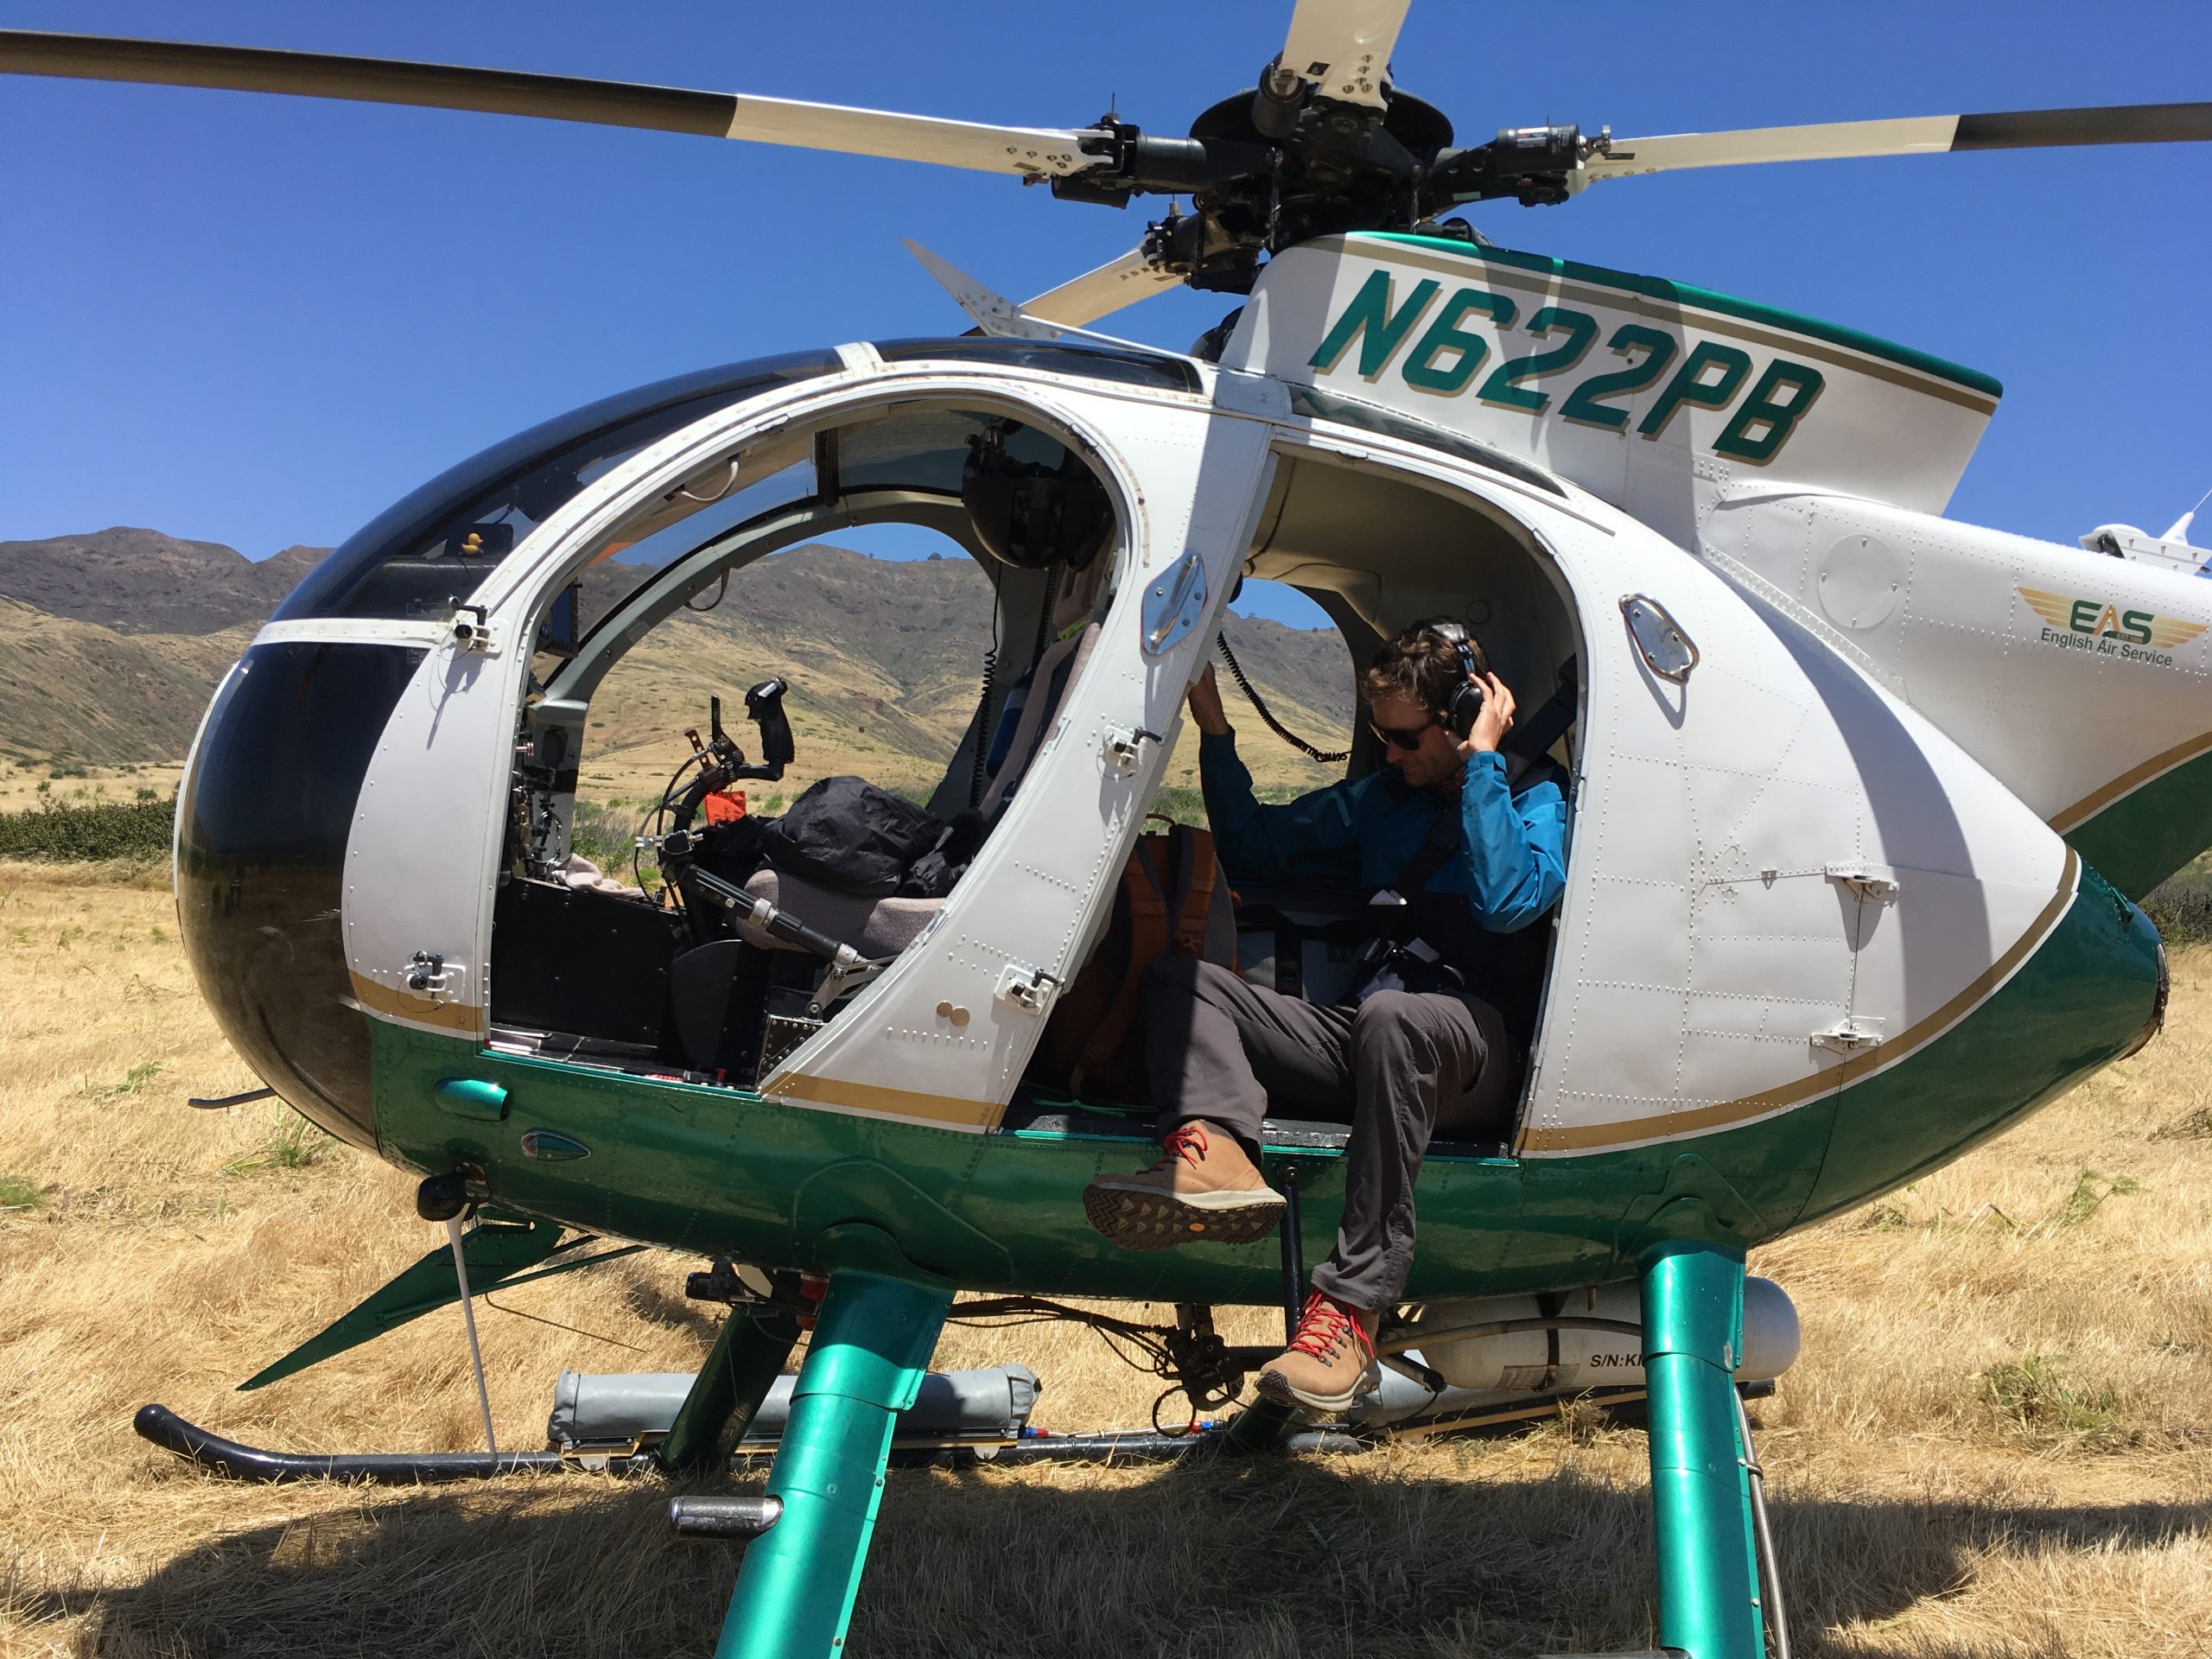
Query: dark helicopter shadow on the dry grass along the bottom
[{"left": 52, "top": 1451, "right": 2212, "bottom": 1659}]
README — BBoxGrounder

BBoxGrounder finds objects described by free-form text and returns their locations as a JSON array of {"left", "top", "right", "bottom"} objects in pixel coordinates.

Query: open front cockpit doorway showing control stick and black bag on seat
[{"left": 491, "top": 403, "right": 1126, "bottom": 1086}]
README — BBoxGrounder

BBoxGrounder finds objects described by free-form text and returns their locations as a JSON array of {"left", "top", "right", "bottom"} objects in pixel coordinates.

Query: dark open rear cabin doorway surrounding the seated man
[{"left": 1018, "top": 445, "right": 1581, "bottom": 1154}]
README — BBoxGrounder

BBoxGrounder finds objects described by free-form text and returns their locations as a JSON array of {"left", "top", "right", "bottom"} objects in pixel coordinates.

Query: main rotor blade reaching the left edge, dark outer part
[{"left": 0, "top": 29, "right": 1103, "bottom": 179}]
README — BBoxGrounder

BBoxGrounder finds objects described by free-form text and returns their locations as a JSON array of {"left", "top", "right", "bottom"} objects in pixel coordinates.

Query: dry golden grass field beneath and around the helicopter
[{"left": 0, "top": 865, "right": 2212, "bottom": 1659}]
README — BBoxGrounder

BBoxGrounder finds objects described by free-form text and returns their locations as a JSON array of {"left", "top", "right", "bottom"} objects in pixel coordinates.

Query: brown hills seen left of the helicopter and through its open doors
[{"left": 0, "top": 529, "right": 1351, "bottom": 785}]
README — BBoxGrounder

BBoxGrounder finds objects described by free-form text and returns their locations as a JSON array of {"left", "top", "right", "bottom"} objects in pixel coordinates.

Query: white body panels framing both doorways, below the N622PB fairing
[{"left": 285, "top": 311, "right": 2073, "bottom": 1157}]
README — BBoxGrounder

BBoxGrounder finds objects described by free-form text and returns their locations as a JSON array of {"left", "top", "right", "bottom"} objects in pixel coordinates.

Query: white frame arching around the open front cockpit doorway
[{"left": 347, "top": 376, "right": 1268, "bottom": 1130}]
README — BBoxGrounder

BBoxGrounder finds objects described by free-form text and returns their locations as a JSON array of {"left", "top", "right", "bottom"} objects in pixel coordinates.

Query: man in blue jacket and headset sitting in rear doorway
[{"left": 1084, "top": 620, "right": 1566, "bottom": 1411}]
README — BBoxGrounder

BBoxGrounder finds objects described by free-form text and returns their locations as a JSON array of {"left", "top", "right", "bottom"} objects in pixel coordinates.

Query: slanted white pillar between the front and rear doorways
[{"left": 743, "top": 391, "right": 1268, "bottom": 1130}]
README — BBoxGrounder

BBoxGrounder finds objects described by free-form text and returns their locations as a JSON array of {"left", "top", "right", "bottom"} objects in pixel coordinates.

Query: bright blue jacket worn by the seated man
[{"left": 1199, "top": 732, "right": 1566, "bottom": 933}]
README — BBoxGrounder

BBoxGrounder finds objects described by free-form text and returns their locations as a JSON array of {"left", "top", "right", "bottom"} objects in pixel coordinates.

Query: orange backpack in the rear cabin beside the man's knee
[{"left": 1038, "top": 823, "right": 1236, "bottom": 1099}]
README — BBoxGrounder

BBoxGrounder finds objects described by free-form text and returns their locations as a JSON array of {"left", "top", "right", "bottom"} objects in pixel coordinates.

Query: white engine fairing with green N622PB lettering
[{"left": 1224, "top": 237, "right": 1998, "bottom": 546}]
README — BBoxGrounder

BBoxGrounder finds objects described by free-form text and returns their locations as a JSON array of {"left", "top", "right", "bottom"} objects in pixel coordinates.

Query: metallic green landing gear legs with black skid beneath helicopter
[{"left": 135, "top": 1224, "right": 1787, "bottom": 1659}]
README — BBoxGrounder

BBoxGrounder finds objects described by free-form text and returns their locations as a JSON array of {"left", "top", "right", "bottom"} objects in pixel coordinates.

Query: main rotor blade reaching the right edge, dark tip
[{"left": 1584, "top": 104, "right": 2212, "bottom": 181}]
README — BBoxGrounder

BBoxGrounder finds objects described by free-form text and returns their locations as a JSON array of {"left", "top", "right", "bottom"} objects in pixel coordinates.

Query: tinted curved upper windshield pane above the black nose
[{"left": 276, "top": 352, "right": 841, "bottom": 621}]
